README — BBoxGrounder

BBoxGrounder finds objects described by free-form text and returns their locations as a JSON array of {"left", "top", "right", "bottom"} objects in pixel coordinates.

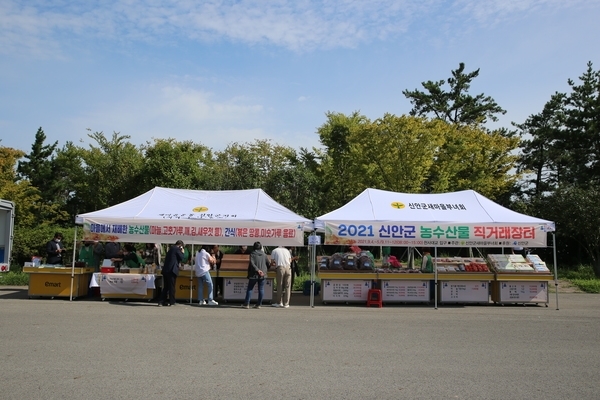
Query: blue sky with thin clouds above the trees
[{"left": 0, "top": 0, "right": 600, "bottom": 152}]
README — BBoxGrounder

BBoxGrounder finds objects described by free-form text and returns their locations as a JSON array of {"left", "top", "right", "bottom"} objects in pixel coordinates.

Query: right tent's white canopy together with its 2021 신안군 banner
[{"left": 315, "top": 189, "right": 558, "bottom": 308}]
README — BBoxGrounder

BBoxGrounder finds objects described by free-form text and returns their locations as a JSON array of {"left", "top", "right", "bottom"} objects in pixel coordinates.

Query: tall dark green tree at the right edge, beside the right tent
[{"left": 516, "top": 63, "right": 600, "bottom": 276}]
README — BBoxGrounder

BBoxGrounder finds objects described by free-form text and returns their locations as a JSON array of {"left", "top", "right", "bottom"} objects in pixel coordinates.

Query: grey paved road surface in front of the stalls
[{"left": 0, "top": 287, "right": 600, "bottom": 400}]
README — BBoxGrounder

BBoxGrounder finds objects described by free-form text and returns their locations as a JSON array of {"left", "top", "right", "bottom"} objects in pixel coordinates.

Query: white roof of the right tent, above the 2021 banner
[{"left": 315, "top": 189, "right": 554, "bottom": 230}]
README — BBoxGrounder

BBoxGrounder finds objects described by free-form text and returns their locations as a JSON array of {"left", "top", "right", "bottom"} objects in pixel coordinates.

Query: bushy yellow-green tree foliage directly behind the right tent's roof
[{"left": 322, "top": 114, "right": 518, "bottom": 206}]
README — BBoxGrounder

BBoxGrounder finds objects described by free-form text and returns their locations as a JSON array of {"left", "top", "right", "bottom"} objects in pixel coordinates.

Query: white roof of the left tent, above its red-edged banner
[{"left": 77, "top": 187, "right": 311, "bottom": 225}]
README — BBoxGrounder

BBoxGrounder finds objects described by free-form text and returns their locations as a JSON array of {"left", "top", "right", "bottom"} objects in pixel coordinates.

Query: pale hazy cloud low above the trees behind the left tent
[{"left": 63, "top": 83, "right": 274, "bottom": 149}]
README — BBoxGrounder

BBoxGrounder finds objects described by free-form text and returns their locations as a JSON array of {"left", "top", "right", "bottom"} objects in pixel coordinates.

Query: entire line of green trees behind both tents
[{"left": 0, "top": 62, "right": 600, "bottom": 276}]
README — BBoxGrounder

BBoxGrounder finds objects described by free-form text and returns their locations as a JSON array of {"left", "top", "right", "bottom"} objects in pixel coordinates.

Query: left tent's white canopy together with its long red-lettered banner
[{"left": 77, "top": 187, "right": 312, "bottom": 246}]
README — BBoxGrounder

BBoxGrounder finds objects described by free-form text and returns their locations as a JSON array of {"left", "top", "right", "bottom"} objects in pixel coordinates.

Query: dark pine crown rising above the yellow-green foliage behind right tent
[{"left": 402, "top": 63, "right": 506, "bottom": 125}]
